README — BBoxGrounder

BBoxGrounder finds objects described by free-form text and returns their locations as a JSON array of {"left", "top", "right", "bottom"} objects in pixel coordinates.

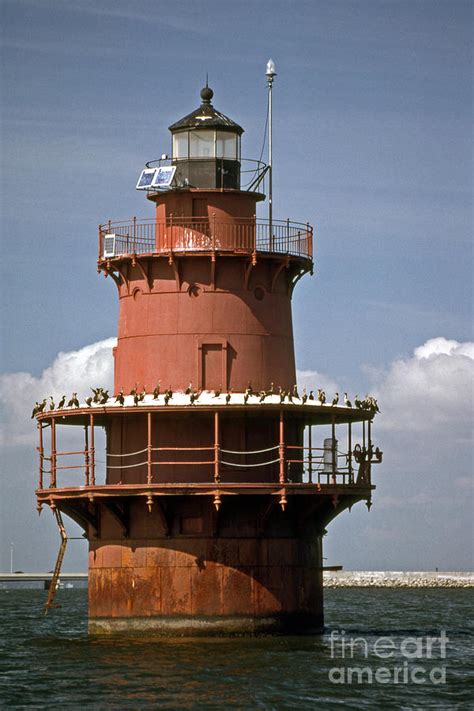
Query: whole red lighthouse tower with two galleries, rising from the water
[{"left": 36, "top": 79, "right": 381, "bottom": 634}]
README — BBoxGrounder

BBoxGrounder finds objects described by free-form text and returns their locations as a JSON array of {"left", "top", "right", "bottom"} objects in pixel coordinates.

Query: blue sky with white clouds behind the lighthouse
[{"left": 0, "top": 0, "right": 474, "bottom": 570}]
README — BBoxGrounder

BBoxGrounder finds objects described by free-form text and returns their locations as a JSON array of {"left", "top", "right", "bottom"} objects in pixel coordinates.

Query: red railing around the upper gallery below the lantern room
[{"left": 99, "top": 215, "right": 313, "bottom": 259}]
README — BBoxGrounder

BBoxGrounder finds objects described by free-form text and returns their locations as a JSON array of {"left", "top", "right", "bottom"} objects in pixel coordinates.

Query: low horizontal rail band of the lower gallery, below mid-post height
[{"left": 38, "top": 444, "right": 370, "bottom": 489}]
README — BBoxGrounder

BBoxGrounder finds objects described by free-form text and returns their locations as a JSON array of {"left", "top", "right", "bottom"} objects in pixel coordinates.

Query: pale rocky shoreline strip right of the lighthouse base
[{"left": 323, "top": 570, "right": 474, "bottom": 588}]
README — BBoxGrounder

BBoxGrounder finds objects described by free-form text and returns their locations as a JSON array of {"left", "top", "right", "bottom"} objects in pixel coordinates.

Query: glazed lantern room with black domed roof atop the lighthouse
[{"left": 169, "top": 84, "right": 244, "bottom": 190}]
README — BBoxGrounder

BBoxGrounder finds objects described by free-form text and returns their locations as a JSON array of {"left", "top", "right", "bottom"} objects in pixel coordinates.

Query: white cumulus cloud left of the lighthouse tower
[{"left": 0, "top": 338, "right": 116, "bottom": 445}]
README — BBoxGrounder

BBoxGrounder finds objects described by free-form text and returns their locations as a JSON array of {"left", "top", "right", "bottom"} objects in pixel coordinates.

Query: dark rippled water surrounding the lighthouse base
[{"left": 0, "top": 588, "right": 474, "bottom": 711}]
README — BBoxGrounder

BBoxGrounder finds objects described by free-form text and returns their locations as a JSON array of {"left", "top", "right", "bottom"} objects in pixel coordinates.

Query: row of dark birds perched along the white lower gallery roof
[{"left": 31, "top": 381, "right": 380, "bottom": 418}]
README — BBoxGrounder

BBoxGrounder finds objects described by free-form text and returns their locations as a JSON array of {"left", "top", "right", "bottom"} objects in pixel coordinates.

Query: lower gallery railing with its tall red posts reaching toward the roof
[{"left": 38, "top": 411, "right": 382, "bottom": 489}]
